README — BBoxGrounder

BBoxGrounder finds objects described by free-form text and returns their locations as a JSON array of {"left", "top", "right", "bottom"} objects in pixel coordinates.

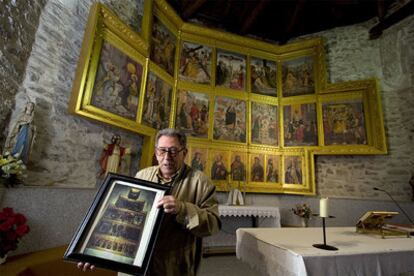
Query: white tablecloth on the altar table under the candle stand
[{"left": 236, "top": 227, "right": 414, "bottom": 276}]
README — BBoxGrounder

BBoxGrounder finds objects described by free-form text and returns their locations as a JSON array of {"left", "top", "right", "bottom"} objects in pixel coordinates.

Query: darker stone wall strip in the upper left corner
[{"left": 0, "top": 0, "right": 46, "bottom": 147}]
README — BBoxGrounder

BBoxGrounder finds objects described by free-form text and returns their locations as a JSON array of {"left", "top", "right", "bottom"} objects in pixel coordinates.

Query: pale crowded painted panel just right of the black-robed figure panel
[{"left": 251, "top": 102, "right": 279, "bottom": 146}]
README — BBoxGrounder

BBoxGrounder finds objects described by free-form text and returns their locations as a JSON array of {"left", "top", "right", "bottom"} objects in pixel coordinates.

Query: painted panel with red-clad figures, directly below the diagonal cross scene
[{"left": 175, "top": 90, "right": 209, "bottom": 138}]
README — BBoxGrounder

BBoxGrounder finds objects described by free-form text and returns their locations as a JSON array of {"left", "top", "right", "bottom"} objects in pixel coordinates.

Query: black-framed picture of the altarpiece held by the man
[{"left": 64, "top": 173, "right": 170, "bottom": 275}]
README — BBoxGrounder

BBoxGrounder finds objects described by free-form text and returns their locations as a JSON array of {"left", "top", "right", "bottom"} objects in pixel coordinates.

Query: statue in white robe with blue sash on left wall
[{"left": 5, "top": 102, "right": 36, "bottom": 164}]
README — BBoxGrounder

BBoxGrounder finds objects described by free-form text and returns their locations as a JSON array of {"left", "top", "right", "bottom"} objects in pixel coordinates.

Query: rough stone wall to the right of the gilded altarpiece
[{"left": 308, "top": 16, "right": 414, "bottom": 201}]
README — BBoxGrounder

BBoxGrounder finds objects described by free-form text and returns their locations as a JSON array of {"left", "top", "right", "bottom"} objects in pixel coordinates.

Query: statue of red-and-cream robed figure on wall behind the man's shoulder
[{"left": 99, "top": 134, "right": 131, "bottom": 176}]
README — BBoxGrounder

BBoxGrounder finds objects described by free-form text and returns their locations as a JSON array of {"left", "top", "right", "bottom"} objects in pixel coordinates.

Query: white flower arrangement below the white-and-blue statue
[{"left": 0, "top": 152, "right": 26, "bottom": 187}]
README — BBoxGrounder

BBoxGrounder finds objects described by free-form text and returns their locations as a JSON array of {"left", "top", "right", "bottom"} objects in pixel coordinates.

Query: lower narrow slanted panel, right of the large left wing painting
[{"left": 142, "top": 72, "right": 172, "bottom": 129}]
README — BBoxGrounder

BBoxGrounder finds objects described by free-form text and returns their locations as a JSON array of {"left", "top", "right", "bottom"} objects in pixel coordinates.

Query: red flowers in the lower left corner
[{"left": 0, "top": 207, "right": 30, "bottom": 258}]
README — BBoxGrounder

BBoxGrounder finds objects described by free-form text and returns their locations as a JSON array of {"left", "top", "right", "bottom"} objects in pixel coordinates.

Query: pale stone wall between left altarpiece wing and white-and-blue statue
[{"left": 3, "top": 0, "right": 142, "bottom": 188}]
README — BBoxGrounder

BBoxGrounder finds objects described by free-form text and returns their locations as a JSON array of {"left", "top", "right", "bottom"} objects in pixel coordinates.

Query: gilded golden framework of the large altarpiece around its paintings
[{"left": 71, "top": 0, "right": 387, "bottom": 195}]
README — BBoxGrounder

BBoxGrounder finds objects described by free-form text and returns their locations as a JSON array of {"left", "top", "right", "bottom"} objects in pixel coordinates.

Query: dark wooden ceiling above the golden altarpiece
[{"left": 167, "top": 0, "right": 414, "bottom": 44}]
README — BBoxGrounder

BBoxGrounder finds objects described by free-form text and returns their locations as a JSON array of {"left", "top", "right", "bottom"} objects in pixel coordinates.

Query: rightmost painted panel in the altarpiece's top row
[{"left": 282, "top": 56, "right": 315, "bottom": 97}]
